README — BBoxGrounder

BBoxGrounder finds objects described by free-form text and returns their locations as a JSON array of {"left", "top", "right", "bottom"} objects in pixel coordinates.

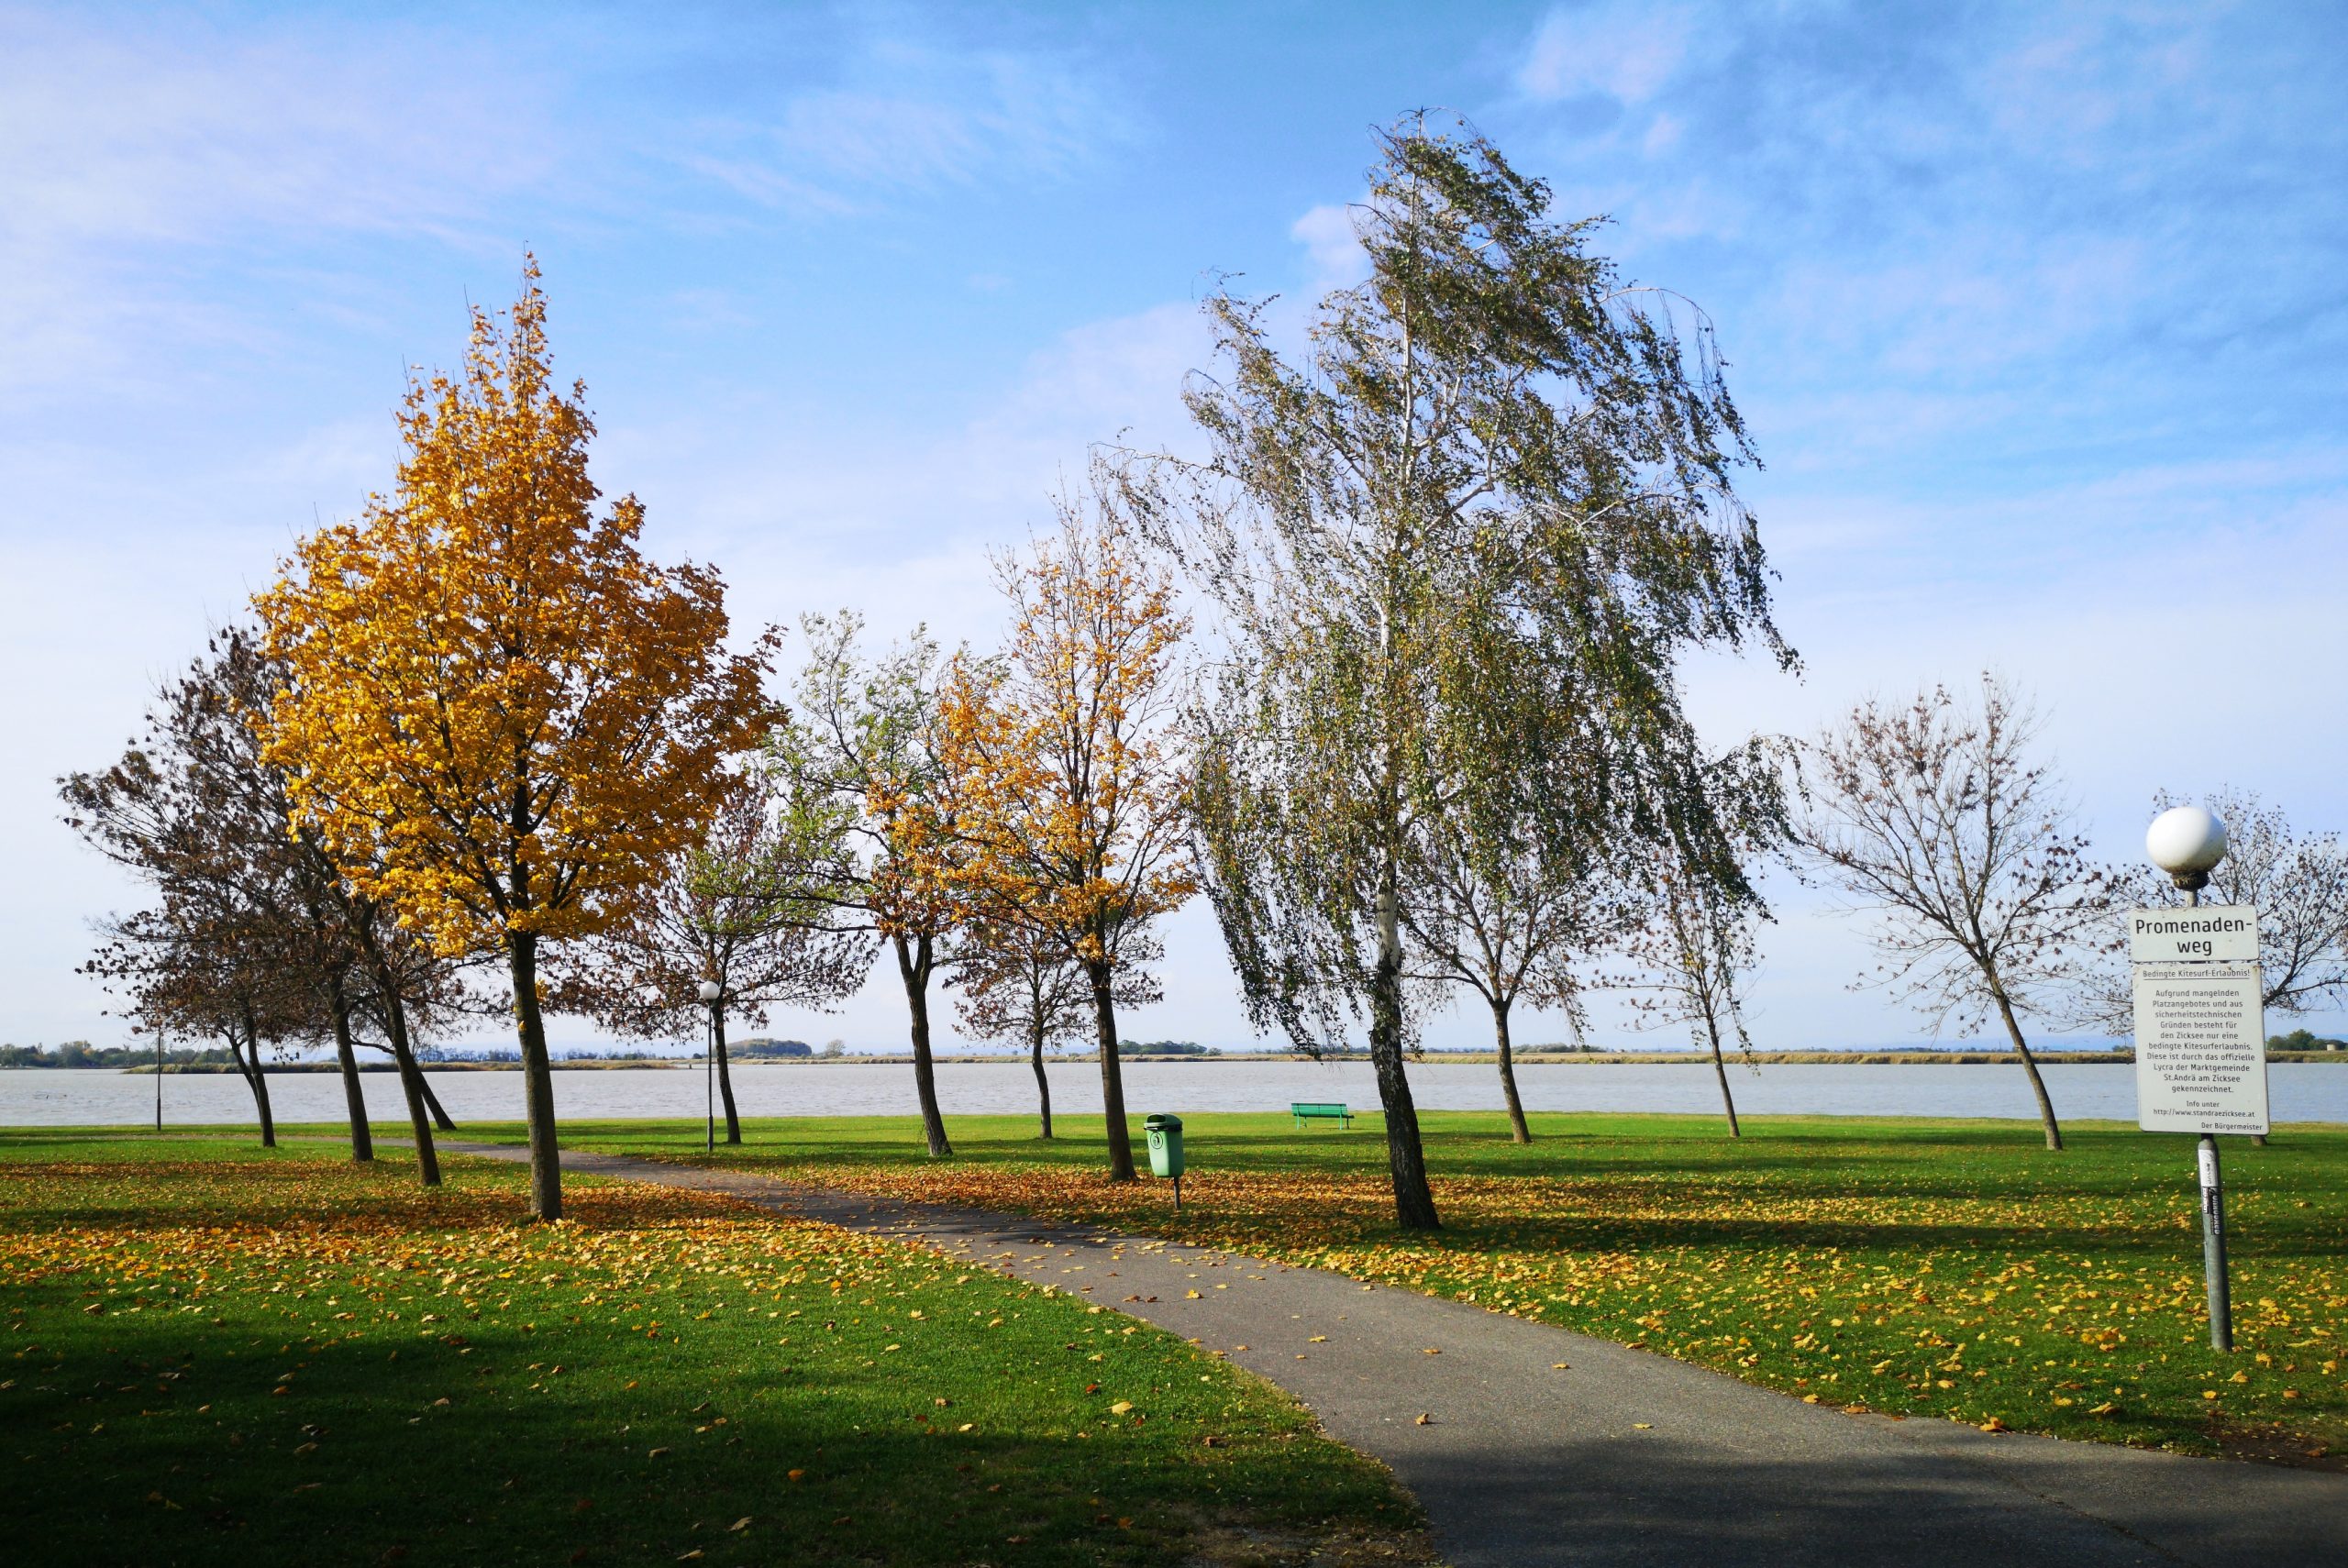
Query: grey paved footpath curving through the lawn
[{"left": 441, "top": 1143, "right": 2348, "bottom": 1568}]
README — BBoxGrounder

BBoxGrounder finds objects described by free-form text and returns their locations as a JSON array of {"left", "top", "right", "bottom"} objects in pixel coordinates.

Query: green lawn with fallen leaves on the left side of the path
[{"left": 0, "top": 1132, "right": 1427, "bottom": 1568}]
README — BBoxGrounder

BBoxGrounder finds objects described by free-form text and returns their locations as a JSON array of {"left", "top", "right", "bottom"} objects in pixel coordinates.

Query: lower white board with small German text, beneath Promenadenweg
[{"left": 2137, "top": 962, "right": 2265, "bottom": 1133}]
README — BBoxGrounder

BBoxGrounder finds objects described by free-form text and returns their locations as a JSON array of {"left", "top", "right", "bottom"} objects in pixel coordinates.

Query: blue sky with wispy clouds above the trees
[{"left": 0, "top": 5, "right": 2348, "bottom": 1044}]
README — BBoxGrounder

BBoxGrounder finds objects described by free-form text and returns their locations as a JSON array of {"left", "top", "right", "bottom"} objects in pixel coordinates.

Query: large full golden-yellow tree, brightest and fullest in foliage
[{"left": 256, "top": 263, "right": 772, "bottom": 1220}]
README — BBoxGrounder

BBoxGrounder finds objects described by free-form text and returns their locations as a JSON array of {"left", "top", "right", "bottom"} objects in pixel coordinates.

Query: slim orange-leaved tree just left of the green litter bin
[{"left": 939, "top": 493, "right": 1198, "bottom": 1181}]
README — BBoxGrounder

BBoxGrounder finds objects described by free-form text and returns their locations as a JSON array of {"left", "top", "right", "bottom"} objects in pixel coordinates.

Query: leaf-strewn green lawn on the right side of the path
[{"left": 514, "top": 1112, "right": 2348, "bottom": 1464}]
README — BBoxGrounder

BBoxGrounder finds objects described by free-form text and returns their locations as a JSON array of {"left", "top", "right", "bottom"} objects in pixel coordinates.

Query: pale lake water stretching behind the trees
[{"left": 14, "top": 1059, "right": 2348, "bottom": 1127}]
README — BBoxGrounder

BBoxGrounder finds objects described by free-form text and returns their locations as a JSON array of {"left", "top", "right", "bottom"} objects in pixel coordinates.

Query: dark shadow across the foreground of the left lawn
[{"left": 0, "top": 1317, "right": 1401, "bottom": 1568}]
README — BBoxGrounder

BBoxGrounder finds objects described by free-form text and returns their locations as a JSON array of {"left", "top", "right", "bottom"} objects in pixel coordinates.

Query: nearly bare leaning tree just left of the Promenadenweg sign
[{"left": 1796, "top": 674, "right": 2110, "bottom": 1150}]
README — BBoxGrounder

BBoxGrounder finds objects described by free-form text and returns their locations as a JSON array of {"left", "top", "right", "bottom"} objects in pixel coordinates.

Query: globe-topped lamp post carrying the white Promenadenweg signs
[{"left": 2127, "top": 805, "right": 2265, "bottom": 1350}]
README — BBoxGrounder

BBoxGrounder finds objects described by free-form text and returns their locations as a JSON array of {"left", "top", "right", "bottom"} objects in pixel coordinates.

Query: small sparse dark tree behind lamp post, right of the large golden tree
[{"left": 549, "top": 767, "right": 873, "bottom": 1143}]
